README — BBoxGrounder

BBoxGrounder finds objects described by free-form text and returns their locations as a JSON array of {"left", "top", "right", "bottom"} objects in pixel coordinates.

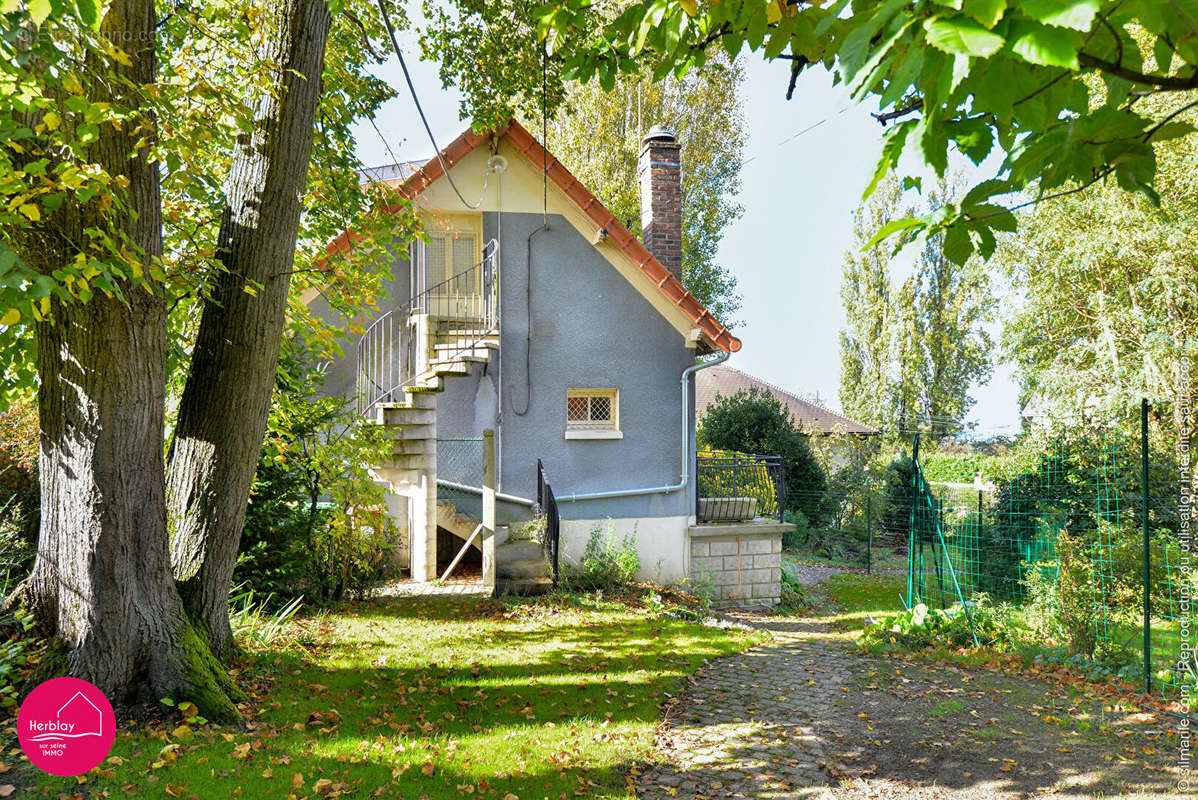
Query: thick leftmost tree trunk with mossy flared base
[{"left": 22, "top": 0, "right": 240, "bottom": 720}]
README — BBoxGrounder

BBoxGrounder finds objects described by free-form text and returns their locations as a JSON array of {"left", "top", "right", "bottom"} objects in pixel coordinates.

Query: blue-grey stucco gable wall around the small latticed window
[{"left": 481, "top": 213, "right": 695, "bottom": 519}]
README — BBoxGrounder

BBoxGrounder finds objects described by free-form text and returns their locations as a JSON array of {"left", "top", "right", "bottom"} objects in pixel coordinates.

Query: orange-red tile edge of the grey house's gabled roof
[{"left": 327, "top": 120, "right": 740, "bottom": 353}]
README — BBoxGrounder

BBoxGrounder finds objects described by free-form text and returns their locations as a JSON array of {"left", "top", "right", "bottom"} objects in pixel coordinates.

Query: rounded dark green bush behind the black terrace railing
[{"left": 697, "top": 387, "right": 828, "bottom": 521}]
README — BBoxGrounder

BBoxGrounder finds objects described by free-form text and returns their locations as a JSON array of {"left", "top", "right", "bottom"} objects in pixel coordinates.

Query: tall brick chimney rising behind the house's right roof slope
[{"left": 636, "top": 126, "right": 682, "bottom": 280}]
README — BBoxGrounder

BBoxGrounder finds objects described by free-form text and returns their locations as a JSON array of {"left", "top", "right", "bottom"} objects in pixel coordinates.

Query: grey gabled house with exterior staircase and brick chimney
[{"left": 310, "top": 121, "right": 780, "bottom": 601}]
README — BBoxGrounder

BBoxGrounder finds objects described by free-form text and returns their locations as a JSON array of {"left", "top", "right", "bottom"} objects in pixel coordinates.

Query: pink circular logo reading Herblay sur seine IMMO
[{"left": 17, "top": 678, "right": 116, "bottom": 776}]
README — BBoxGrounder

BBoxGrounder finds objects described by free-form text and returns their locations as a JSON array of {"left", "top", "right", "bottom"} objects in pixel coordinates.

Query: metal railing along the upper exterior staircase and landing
[{"left": 357, "top": 240, "right": 500, "bottom": 413}]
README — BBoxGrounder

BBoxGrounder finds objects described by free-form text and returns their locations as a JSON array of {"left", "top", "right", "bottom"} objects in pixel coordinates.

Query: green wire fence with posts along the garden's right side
[{"left": 903, "top": 401, "right": 1198, "bottom": 695}]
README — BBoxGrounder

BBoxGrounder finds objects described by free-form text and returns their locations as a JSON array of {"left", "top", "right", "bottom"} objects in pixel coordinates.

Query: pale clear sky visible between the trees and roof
[{"left": 355, "top": 26, "right": 1019, "bottom": 432}]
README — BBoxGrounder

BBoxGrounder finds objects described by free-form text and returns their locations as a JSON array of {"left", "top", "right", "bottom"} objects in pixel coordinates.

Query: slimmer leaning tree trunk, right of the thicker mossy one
[{"left": 168, "top": 0, "right": 331, "bottom": 657}]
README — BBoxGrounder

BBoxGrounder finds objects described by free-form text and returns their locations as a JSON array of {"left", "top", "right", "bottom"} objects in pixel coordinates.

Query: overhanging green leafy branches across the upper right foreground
[{"left": 534, "top": 0, "right": 1198, "bottom": 263}]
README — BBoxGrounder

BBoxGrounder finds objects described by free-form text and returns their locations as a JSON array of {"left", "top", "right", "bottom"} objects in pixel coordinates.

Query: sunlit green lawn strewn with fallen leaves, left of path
[{"left": 6, "top": 596, "right": 756, "bottom": 800}]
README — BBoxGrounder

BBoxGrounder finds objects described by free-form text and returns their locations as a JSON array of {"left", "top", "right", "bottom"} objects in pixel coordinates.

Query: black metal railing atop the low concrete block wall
[{"left": 695, "top": 450, "right": 786, "bottom": 522}]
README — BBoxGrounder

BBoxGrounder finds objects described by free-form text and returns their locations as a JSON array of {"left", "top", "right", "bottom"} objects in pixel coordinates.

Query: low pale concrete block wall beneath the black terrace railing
[{"left": 690, "top": 523, "right": 782, "bottom": 608}]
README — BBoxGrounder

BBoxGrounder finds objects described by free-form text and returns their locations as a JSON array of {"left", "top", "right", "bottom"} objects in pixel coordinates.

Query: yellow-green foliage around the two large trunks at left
[{"left": 0, "top": 0, "right": 416, "bottom": 408}]
